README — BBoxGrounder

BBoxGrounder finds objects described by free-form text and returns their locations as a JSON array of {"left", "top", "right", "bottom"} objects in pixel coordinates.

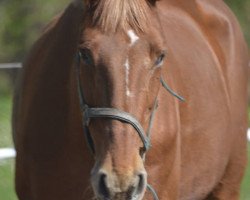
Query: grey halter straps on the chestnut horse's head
[{"left": 76, "top": 52, "right": 185, "bottom": 200}]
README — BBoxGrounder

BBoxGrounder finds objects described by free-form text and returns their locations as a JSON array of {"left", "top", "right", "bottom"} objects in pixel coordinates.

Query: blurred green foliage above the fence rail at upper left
[{"left": 0, "top": 0, "right": 70, "bottom": 62}]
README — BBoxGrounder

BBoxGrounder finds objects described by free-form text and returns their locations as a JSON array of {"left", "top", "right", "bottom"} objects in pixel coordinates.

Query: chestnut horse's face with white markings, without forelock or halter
[{"left": 79, "top": 3, "right": 165, "bottom": 200}]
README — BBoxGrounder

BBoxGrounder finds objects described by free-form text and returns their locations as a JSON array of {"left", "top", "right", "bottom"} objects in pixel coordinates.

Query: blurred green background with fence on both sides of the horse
[{"left": 0, "top": 0, "right": 250, "bottom": 200}]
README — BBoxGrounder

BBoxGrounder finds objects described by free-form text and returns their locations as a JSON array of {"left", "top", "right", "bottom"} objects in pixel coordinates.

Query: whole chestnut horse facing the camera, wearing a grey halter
[{"left": 13, "top": 0, "right": 248, "bottom": 200}]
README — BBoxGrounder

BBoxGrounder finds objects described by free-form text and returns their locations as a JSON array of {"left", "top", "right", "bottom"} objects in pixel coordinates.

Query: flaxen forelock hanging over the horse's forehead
[{"left": 93, "top": 0, "right": 149, "bottom": 32}]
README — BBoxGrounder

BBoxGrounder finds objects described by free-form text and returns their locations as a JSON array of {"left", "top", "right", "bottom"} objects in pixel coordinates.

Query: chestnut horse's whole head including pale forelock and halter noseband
[{"left": 77, "top": 0, "right": 166, "bottom": 200}]
